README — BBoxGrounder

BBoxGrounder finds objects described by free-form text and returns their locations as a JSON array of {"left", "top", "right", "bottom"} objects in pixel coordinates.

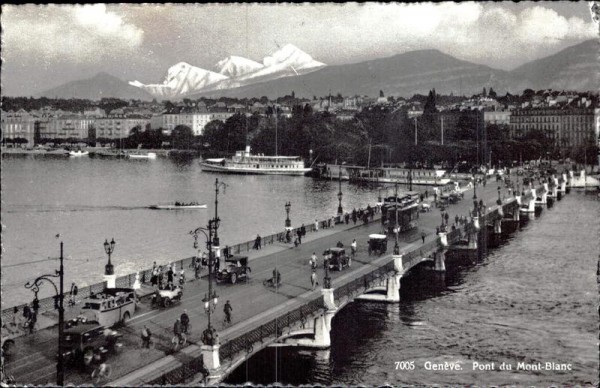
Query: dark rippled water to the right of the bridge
[{"left": 227, "top": 193, "right": 600, "bottom": 386}]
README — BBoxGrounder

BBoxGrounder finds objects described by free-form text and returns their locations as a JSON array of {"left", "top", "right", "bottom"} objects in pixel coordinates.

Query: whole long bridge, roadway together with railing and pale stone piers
[{"left": 3, "top": 177, "right": 566, "bottom": 386}]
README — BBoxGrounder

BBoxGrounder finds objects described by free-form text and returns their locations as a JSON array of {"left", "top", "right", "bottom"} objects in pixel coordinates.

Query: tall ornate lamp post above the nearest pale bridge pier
[{"left": 190, "top": 218, "right": 220, "bottom": 346}]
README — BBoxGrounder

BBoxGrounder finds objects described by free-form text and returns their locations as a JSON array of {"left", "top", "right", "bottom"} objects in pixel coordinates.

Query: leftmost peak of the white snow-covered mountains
[{"left": 129, "top": 62, "right": 228, "bottom": 98}]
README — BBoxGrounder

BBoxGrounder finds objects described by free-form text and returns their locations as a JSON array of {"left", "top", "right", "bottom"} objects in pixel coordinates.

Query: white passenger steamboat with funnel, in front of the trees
[{"left": 200, "top": 146, "right": 311, "bottom": 175}]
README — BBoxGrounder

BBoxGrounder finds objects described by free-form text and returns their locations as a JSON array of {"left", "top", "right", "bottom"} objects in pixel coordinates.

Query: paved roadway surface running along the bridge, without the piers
[{"left": 6, "top": 182, "right": 506, "bottom": 385}]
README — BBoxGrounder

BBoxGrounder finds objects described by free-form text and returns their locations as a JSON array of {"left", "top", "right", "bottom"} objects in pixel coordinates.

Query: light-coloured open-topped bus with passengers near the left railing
[{"left": 80, "top": 288, "right": 137, "bottom": 327}]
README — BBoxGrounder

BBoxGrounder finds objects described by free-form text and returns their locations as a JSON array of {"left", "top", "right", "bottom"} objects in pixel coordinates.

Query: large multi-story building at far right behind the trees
[{"left": 510, "top": 99, "right": 598, "bottom": 148}]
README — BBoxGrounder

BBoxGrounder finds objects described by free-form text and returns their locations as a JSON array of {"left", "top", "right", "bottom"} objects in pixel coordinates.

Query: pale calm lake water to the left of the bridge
[{"left": 1, "top": 155, "right": 394, "bottom": 306}]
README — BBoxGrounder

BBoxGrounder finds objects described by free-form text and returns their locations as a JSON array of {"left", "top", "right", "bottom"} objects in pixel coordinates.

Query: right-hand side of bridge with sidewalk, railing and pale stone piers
[{"left": 111, "top": 175, "right": 566, "bottom": 385}]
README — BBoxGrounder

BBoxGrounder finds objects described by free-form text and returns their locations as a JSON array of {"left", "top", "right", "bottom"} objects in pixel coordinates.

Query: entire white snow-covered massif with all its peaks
[{"left": 129, "top": 44, "right": 326, "bottom": 98}]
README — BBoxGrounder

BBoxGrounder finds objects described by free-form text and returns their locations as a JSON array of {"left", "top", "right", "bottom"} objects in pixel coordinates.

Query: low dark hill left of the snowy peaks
[{"left": 38, "top": 73, "right": 152, "bottom": 101}]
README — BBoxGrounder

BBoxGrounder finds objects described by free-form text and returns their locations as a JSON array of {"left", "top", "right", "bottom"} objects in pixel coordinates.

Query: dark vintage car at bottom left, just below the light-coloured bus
[{"left": 59, "top": 322, "right": 123, "bottom": 366}]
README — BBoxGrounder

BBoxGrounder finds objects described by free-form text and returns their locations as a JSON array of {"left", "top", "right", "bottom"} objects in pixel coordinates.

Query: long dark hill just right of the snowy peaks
[{"left": 194, "top": 50, "right": 512, "bottom": 98}]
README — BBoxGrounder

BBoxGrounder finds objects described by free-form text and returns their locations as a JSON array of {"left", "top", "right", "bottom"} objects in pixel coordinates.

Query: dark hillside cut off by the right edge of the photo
[{"left": 510, "top": 40, "right": 600, "bottom": 92}]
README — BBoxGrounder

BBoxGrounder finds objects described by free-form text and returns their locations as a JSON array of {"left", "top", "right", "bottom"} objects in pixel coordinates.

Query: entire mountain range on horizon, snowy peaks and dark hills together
[{"left": 40, "top": 40, "right": 600, "bottom": 100}]
